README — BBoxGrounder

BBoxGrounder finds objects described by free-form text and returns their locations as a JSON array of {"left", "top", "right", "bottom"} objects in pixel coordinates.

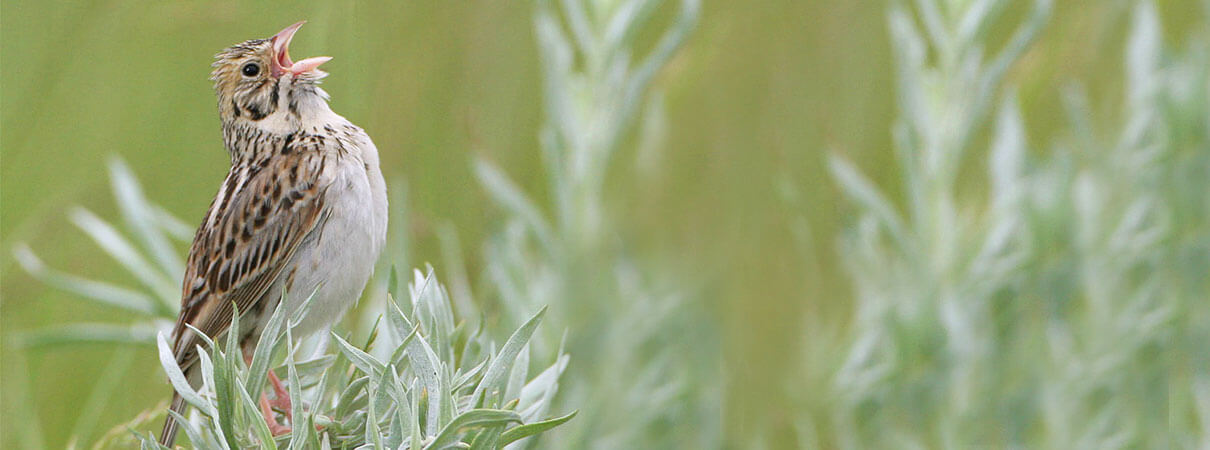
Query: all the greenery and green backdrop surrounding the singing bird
[{"left": 0, "top": 0, "right": 1210, "bottom": 449}]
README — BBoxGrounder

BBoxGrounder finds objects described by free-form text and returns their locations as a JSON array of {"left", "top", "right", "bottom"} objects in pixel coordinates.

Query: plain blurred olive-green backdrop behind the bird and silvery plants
[{"left": 0, "top": 0, "right": 1204, "bottom": 448}]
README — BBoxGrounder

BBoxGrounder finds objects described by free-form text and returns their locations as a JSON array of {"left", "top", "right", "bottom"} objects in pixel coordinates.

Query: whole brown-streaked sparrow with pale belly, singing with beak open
[{"left": 160, "top": 21, "right": 387, "bottom": 446}]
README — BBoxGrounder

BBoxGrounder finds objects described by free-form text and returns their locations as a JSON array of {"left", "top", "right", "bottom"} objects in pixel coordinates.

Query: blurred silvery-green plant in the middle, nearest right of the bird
[{"left": 477, "top": 0, "right": 721, "bottom": 449}]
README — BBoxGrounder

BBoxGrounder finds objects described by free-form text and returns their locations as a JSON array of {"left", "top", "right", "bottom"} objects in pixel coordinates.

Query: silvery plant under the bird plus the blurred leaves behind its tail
[{"left": 16, "top": 158, "right": 575, "bottom": 449}]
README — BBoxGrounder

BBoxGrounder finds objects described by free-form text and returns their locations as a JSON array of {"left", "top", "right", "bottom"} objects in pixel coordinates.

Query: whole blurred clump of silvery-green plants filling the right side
[{"left": 799, "top": 0, "right": 1210, "bottom": 449}]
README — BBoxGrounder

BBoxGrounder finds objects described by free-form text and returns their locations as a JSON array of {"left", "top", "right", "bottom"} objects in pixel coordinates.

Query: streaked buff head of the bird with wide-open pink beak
[{"left": 211, "top": 21, "right": 332, "bottom": 122}]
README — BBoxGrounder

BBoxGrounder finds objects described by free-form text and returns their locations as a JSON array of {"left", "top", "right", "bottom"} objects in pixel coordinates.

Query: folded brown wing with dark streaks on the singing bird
[{"left": 173, "top": 147, "right": 327, "bottom": 369}]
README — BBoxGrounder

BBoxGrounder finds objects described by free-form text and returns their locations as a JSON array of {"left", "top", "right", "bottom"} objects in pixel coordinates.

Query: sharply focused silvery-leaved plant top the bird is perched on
[{"left": 128, "top": 271, "right": 575, "bottom": 449}]
